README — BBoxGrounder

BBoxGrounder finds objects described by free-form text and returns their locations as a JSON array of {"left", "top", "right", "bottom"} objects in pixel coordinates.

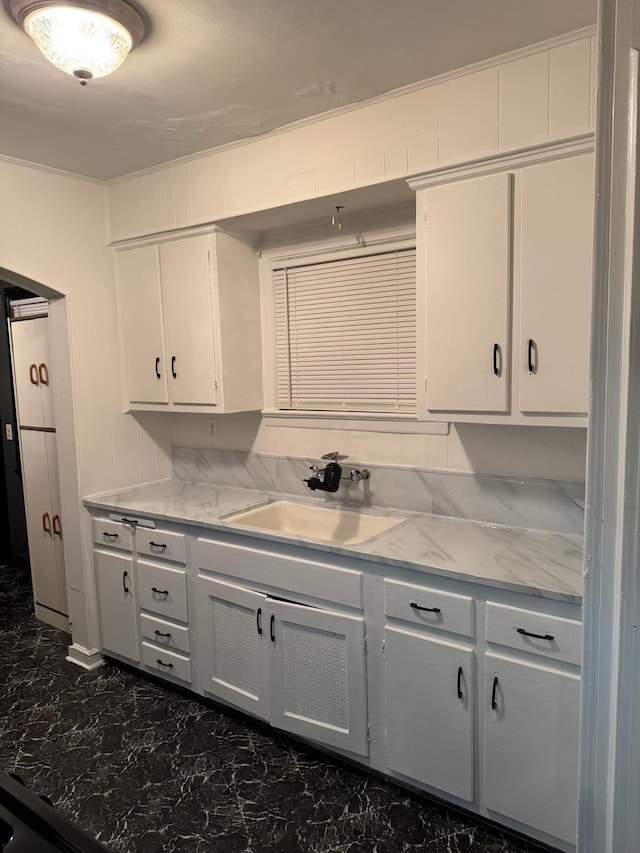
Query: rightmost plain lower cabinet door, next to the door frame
[{"left": 483, "top": 654, "right": 580, "bottom": 844}]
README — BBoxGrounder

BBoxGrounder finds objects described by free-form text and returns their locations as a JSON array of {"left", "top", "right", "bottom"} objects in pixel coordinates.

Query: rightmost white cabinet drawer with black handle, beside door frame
[{"left": 487, "top": 601, "right": 582, "bottom": 666}]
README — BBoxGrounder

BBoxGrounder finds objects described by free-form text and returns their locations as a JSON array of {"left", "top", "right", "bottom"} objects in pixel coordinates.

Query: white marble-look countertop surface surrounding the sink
[{"left": 84, "top": 480, "right": 583, "bottom": 603}]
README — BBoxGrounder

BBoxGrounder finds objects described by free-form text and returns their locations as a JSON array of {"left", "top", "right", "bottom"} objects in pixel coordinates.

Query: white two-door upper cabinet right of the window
[{"left": 411, "top": 149, "right": 594, "bottom": 426}]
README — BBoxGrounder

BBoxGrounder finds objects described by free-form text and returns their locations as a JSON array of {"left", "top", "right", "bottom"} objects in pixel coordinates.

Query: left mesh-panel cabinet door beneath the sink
[{"left": 196, "top": 575, "right": 269, "bottom": 720}]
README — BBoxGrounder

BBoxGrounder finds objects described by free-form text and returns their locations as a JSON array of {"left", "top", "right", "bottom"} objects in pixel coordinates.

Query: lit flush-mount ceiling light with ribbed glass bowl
[{"left": 9, "top": 0, "right": 145, "bottom": 86}]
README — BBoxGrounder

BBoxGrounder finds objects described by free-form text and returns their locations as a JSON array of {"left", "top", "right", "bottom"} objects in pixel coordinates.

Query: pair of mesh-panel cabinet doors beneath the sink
[{"left": 197, "top": 575, "right": 368, "bottom": 755}]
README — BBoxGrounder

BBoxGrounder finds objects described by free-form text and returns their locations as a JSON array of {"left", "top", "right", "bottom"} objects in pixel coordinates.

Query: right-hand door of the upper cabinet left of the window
[{"left": 160, "top": 235, "right": 217, "bottom": 404}]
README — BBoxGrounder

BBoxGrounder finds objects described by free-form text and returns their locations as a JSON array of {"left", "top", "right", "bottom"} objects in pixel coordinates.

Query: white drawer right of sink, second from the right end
[{"left": 384, "top": 580, "right": 475, "bottom": 637}]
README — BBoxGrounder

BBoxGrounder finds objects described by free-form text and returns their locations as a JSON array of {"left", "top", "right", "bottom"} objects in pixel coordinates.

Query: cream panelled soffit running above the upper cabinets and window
[{"left": 109, "top": 30, "right": 596, "bottom": 240}]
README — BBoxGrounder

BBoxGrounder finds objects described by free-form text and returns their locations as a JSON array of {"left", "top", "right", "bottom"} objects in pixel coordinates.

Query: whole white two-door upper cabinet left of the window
[{"left": 118, "top": 230, "right": 262, "bottom": 412}]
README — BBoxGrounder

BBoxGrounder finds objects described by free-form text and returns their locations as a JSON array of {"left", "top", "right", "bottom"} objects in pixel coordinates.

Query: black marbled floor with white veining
[{"left": 0, "top": 567, "right": 552, "bottom": 853}]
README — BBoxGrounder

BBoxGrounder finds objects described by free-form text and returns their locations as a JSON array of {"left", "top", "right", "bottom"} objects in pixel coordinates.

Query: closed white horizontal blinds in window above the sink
[{"left": 273, "top": 249, "right": 416, "bottom": 413}]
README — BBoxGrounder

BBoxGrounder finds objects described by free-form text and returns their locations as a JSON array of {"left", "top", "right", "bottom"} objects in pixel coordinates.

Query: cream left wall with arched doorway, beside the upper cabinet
[{"left": 0, "top": 159, "right": 170, "bottom": 647}]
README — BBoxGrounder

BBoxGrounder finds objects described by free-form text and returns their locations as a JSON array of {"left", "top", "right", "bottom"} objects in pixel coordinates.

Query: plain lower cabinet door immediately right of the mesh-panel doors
[{"left": 385, "top": 628, "right": 474, "bottom": 802}]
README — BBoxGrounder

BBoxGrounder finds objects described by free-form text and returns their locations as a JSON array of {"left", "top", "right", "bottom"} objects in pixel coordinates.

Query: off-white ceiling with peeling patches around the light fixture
[{"left": 0, "top": 0, "right": 596, "bottom": 179}]
